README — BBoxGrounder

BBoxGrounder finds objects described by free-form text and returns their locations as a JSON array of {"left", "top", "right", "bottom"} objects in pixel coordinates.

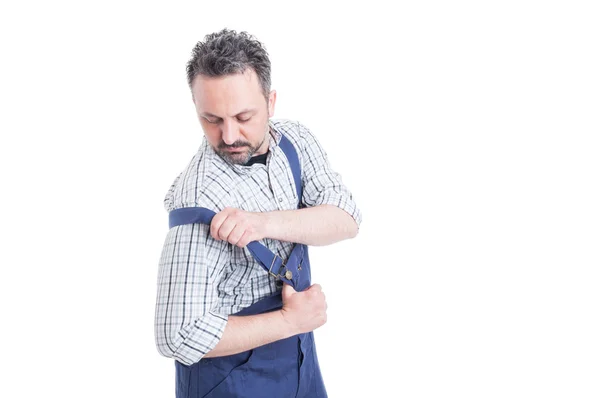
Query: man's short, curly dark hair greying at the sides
[{"left": 187, "top": 28, "right": 271, "bottom": 98}]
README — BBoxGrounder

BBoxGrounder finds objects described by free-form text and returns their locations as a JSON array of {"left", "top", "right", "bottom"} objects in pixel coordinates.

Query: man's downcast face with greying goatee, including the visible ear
[{"left": 192, "top": 69, "right": 276, "bottom": 164}]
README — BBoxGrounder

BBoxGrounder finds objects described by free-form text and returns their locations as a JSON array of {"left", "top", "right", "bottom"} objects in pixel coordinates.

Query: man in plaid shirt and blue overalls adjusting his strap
[{"left": 155, "top": 29, "right": 361, "bottom": 398}]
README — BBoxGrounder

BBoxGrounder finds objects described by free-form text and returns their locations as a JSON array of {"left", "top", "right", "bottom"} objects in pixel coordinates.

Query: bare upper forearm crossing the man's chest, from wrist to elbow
[{"left": 262, "top": 205, "right": 358, "bottom": 246}]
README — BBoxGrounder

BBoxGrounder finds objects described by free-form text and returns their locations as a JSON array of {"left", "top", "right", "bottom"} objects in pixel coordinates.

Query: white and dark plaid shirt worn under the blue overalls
[{"left": 154, "top": 119, "right": 361, "bottom": 365}]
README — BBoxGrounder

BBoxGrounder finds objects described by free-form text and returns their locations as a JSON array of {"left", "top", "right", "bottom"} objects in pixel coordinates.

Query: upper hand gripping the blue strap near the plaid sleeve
[{"left": 210, "top": 207, "right": 265, "bottom": 247}]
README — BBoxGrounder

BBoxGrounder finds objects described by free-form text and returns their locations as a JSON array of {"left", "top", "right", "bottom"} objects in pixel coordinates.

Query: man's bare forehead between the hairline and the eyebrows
[{"left": 192, "top": 69, "right": 265, "bottom": 115}]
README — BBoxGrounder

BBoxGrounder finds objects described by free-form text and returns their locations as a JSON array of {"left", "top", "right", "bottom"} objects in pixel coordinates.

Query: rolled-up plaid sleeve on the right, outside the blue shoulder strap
[{"left": 298, "top": 123, "right": 362, "bottom": 227}]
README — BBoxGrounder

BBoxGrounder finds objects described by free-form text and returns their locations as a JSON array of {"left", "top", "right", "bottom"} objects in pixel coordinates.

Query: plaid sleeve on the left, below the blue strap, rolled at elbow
[{"left": 154, "top": 224, "right": 230, "bottom": 365}]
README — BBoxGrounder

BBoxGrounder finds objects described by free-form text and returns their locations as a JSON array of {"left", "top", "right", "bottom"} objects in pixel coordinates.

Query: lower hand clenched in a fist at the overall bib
[{"left": 281, "top": 283, "right": 327, "bottom": 334}]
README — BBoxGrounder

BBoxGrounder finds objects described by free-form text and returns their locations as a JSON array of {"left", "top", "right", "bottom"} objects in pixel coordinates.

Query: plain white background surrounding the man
[{"left": 0, "top": 1, "right": 600, "bottom": 398}]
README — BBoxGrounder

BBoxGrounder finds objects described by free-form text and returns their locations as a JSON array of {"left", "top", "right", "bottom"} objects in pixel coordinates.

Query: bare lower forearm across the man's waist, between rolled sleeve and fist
[{"left": 204, "top": 310, "right": 297, "bottom": 358}]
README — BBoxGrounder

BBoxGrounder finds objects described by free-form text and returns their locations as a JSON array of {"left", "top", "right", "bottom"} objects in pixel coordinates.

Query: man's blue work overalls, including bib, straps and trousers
[{"left": 169, "top": 136, "right": 327, "bottom": 398}]
